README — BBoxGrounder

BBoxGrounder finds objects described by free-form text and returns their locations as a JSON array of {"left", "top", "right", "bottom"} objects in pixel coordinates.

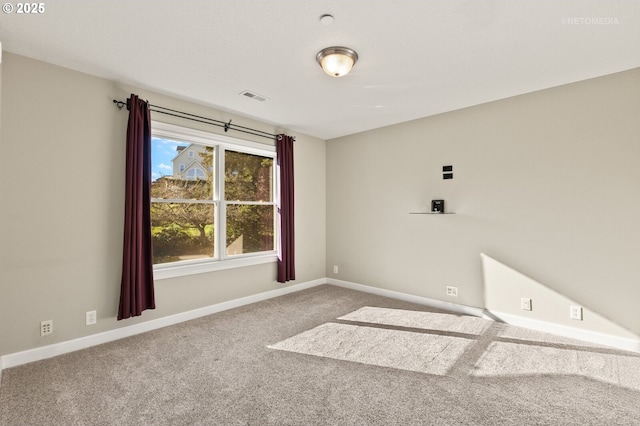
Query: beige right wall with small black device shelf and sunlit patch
[{"left": 326, "top": 69, "right": 640, "bottom": 336}]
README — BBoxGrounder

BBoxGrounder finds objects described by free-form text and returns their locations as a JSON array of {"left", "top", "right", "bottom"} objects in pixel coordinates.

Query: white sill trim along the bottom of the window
[{"left": 153, "top": 253, "right": 278, "bottom": 281}]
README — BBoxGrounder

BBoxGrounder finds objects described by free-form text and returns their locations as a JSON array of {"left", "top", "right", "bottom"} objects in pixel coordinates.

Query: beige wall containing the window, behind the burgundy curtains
[{"left": 0, "top": 53, "right": 326, "bottom": 355}]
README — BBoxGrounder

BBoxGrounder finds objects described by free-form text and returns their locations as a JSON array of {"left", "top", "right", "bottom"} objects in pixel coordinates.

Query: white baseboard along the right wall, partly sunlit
[{"left": 327, "top": 278, "right": 640, "bottom": 353}]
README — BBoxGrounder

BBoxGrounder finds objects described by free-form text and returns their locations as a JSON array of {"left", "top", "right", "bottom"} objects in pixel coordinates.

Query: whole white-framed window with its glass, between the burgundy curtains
[{"left": 151, "top": 122, "right": 277, "bottom": 278}]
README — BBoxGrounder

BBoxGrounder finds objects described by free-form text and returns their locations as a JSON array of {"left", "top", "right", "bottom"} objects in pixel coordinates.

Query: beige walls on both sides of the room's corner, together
[{"left": 0, "top": 48, "right": 640, "bottom": 355}]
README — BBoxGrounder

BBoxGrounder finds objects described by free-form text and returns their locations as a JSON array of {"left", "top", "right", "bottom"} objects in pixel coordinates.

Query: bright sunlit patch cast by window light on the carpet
[{"left": 269, "top": 306, "right": 640, "bottom": 392}]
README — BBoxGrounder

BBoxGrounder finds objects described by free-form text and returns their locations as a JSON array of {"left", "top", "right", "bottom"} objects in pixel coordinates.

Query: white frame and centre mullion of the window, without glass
[{"left": 151, "top": 121, "right": 280, "bottom": 280}]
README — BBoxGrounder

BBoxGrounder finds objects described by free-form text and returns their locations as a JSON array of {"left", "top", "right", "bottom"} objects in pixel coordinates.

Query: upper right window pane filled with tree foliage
[{"left": 224, "top": 151, "right": 273, "bottom": 202}]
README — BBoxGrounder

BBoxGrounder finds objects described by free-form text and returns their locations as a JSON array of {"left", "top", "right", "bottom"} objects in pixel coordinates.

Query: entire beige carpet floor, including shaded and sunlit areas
[{"left": 0, "top": 283, "right": 640, "bottom": 426}]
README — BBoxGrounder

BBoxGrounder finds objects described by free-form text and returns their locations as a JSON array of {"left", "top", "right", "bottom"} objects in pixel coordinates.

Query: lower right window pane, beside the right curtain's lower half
[{"left": 226, "top": 204, "right": 275, "bottom": 256}]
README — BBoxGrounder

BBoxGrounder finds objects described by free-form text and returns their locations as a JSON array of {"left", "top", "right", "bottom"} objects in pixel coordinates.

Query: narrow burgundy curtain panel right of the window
[{"left": 276, "top": 135, "right": 296, "bottom": 283}]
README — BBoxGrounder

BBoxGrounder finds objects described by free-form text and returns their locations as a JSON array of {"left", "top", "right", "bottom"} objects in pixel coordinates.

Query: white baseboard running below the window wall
[{"left": 0, "top": 278, "right": 327, "bottom": 372}]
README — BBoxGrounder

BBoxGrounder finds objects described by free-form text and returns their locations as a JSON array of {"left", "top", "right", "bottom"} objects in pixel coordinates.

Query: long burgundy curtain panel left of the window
[{"left": 118, "top": 94, "right": 156, "bottom": 320}]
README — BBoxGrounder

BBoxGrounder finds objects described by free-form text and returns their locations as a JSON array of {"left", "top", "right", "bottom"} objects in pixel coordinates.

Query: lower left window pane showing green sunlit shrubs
[{"left": 151, "top": 203, "right": 215, "bottom": 263}]
